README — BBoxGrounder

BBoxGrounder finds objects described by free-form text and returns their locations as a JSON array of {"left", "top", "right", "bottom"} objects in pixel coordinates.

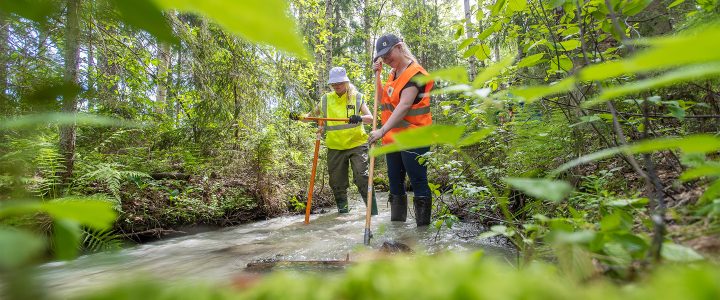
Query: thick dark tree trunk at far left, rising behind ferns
[{"left": 60, "top": 0, "right": 80, "bottom": 184}]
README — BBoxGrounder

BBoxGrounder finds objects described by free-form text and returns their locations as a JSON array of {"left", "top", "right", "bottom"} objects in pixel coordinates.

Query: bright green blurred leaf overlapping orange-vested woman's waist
[{"left": 370, "top": 125, "right": 465, "bottom": 156}]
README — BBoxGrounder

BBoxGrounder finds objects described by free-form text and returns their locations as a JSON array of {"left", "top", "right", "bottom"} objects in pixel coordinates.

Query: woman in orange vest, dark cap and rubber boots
[{"left": 368, "top": 34, "right": 434, "bottom": 226}]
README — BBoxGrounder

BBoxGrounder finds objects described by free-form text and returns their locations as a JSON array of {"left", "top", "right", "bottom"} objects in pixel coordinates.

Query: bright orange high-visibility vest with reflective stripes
[{"left": 380, "top": 62, "right": 434, "bottom": 145}]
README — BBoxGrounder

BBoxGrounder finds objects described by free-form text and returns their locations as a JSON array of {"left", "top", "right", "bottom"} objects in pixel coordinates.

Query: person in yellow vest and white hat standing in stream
[{"left": 292, "top": 67, "right": 378, "bottom": 215}]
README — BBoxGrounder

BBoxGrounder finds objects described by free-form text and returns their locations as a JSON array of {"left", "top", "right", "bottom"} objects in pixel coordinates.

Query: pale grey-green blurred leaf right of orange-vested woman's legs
[{"left": 503, "top": 177, "right": 573, "bottom": 202}]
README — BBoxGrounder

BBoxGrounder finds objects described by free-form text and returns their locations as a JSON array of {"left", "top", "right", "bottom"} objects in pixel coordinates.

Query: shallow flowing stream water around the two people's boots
[{"left": 40, "top": 193, "right": 510, "bottom": 295}]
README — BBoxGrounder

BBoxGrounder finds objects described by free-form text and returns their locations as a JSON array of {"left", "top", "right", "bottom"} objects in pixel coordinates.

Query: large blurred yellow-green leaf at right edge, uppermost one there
[{"left": 579, "top": 23, "right": 720, "bottom": 81}]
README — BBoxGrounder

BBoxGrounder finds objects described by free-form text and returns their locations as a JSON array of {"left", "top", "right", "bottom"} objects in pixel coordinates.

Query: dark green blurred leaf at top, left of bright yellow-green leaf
[{"left": 115, "top": 0, "right": 180, "bottom": 44}]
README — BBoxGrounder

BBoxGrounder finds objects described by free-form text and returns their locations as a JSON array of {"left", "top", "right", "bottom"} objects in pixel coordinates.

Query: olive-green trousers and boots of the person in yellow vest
[{"left": 327, "top": 144, "right": 377, "bottom": 215}]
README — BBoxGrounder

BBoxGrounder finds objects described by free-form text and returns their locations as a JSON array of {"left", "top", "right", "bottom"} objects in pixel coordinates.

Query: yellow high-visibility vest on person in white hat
[{"left": 321, "top": 92, "right": 368, "bottom": 150}]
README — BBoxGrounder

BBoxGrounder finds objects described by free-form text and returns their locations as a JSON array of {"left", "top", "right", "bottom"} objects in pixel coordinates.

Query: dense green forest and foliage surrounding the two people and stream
[{"left": 0, "top": 0, "right": 720, "bottom": 298}]
